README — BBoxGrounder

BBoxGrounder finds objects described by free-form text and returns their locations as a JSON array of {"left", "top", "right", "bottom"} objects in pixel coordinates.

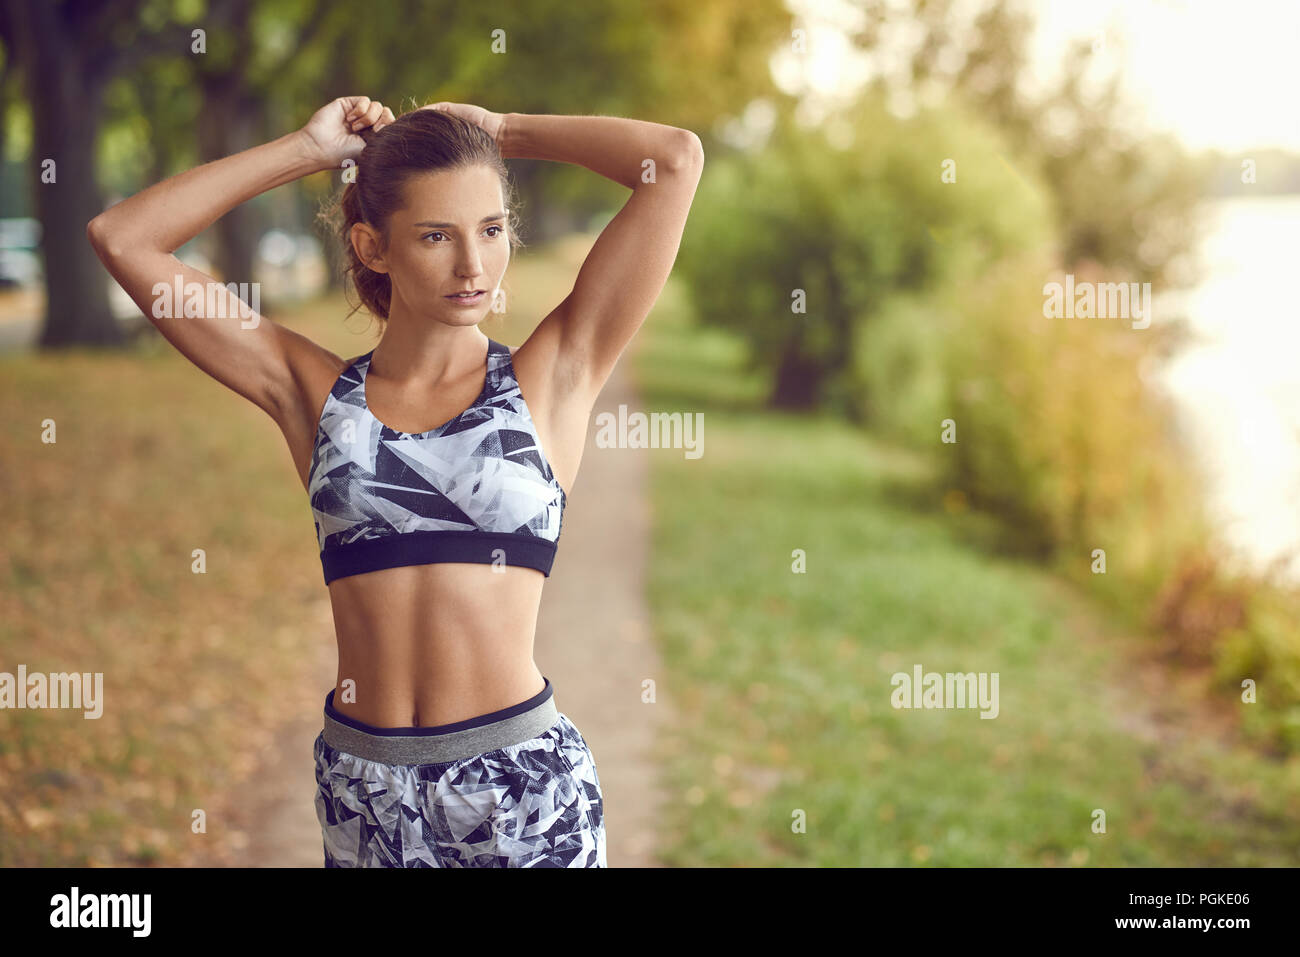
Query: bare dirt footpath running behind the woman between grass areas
[{"left": 232, "top": 330, "right": 671, "bottom": 867}]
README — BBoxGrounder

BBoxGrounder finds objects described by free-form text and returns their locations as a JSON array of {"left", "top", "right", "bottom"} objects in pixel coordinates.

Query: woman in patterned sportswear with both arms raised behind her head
[{"left": 87, "top": 96, "right": 703, "bottom": 867}]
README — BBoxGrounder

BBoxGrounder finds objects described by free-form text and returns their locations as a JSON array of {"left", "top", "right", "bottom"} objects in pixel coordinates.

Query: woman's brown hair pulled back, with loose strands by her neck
[{"left": 320, "top": 109, "right": 523, "bottom": 322}]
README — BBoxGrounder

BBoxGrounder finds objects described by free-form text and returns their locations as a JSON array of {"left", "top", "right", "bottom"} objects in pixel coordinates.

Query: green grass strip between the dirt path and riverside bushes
[{"left": 636, "top": 302, "right": 1300, "bottom": 866}]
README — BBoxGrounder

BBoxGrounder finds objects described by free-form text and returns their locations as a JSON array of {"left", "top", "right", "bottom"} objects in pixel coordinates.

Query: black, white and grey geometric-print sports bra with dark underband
[{"left": 307, "top": 338, "right": 566, "bottom": 585}]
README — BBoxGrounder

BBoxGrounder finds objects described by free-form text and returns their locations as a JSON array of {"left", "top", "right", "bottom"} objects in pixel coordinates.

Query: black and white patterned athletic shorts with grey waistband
[{"left": 315, "top": 677, "right": 607, "bottom": 867}]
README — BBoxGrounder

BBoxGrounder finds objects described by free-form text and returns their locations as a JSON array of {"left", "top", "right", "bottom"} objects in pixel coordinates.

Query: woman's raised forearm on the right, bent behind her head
[{"left": 499, "top": 113, "right": 699, "bottom": 190}]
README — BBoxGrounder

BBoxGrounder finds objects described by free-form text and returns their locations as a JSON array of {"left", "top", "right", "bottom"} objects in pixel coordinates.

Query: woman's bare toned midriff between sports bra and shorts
[{"left": 329, "top": 563, "right": 546, "bottom": 728}]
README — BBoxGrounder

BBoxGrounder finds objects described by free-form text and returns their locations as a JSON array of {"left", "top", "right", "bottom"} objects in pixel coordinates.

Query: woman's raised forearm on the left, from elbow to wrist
[{"left": 90, "top": 130, "right": 322, "bottom": 260}]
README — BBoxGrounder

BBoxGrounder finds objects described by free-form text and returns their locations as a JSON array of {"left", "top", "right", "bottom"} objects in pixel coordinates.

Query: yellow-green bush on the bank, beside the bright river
[{"left": 931, "top": 255, "right": 1208, "bottom": 582}]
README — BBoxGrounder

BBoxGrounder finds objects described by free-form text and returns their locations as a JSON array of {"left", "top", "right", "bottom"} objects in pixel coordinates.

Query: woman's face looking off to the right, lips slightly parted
[{"left": 354, "top": 165, "right": 510, "bottom": 325}]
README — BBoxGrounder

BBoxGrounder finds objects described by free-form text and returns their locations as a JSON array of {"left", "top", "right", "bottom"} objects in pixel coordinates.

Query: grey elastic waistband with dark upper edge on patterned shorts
[{"left": 322, "top": 676, "right": 559, "bottom": 765}]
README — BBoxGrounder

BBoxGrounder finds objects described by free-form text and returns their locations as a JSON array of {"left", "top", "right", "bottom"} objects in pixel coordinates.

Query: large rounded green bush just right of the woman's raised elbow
[{"left": 675, "top": 96, "right": 1052, "bottom": 421}]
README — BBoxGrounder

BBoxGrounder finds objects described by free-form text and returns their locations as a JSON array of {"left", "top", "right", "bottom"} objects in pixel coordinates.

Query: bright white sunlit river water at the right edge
[{"left": 1153, "top": 195, "right": 1300, "bottom": 583}]
